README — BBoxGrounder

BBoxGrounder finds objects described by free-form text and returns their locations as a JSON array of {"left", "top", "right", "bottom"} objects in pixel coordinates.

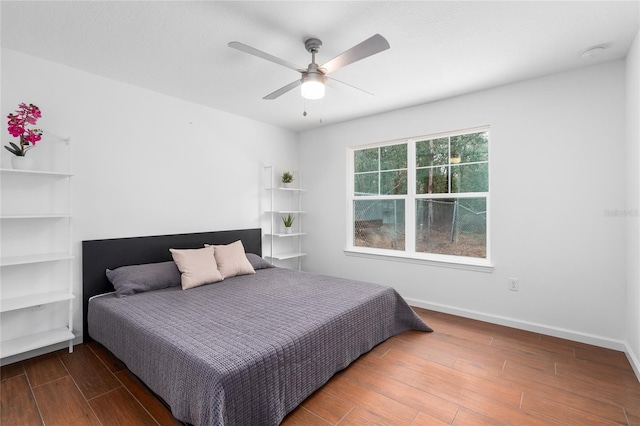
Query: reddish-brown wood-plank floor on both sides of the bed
[{"left": 0, "top": 308, "right": 640, "bottom": 426}]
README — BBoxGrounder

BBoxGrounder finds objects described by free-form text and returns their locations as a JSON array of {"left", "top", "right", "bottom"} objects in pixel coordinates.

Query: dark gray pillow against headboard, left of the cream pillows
[{"left": 106, "top": 261, "right": 181, "bottom": 297}]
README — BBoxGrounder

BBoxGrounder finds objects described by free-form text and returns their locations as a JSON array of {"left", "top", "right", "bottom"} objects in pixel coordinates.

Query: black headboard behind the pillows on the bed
[{"left": 82, "top": 228, "right": 262, "bottom": 342}]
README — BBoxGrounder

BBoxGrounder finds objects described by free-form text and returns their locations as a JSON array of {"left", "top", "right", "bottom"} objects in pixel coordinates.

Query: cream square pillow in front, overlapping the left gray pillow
[{"left": 169, "top": 247, "right": 223, "bottom": 290}]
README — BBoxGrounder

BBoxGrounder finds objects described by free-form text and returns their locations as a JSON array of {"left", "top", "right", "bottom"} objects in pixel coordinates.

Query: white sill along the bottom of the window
[{"left": 344, "top": 247, "right": 494, "bottom": 273}]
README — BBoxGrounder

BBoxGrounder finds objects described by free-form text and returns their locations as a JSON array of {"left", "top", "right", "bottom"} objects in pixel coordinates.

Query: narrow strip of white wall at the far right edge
[{"left": 625, "top": 33, "right": 640, "bottom": 378}]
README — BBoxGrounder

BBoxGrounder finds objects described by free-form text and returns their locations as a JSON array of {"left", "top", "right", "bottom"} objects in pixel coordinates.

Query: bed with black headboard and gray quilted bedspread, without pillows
[{"left": 82, "top": 229, "right": 431, "bottom": 425}]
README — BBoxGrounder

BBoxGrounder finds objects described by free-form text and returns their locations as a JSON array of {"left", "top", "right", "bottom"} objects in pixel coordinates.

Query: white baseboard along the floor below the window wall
[{"left": 405, "top": 298, "right": 628, "bottom": 352}]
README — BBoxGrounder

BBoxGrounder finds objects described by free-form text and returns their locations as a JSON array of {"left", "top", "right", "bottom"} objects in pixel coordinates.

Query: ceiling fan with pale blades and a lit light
[{"left": 229, "top": 34, "right": 390, "bottom": 100}]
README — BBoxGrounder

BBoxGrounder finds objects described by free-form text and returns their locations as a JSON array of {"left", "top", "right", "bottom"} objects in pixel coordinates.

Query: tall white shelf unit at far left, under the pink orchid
[{"left": 0, "top": 132, "right": 75, "bottom": 358}]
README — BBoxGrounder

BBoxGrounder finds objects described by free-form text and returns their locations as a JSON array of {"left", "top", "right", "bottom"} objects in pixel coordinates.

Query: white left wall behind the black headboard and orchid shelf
[{"left": 0, "top": 49, "right": 298, "bottom": 363}]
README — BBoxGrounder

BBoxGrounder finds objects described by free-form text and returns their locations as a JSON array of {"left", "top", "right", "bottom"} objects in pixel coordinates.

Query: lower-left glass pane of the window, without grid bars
[{"left": 353, "top": 200, "right": 405, "bottom": 250}]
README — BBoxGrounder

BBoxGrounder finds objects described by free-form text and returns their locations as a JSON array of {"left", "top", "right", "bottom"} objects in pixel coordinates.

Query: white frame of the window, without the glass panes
[{"left": 344, "top": 126, "right": 493, "bottom": 272}]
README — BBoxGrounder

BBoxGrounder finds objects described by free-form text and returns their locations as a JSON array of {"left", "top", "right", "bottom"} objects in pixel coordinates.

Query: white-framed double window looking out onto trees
[{"left": 348, "top": 128, "right": 489, "bottom": 266}]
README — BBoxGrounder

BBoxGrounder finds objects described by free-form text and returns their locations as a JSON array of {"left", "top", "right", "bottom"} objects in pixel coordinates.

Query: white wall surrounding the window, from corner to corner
[{"left": 300, "top": 61, "right": 626, "bottom": 349}]
